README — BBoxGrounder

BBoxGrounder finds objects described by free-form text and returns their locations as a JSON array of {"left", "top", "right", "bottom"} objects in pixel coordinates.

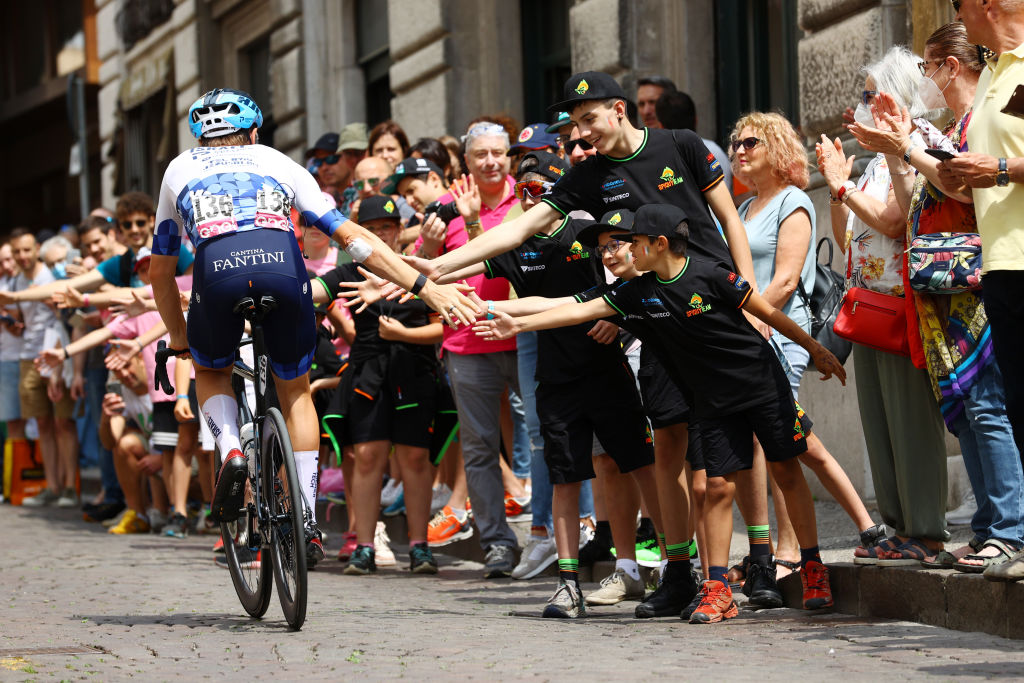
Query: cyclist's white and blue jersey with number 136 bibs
[{"left": 153, "top": 144, "right": 348, "bottom": 258}]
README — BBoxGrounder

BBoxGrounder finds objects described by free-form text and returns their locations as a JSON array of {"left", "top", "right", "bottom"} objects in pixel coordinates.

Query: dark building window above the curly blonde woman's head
[{"left": 715, "top": 0, "right": 803, "bottom": 143}]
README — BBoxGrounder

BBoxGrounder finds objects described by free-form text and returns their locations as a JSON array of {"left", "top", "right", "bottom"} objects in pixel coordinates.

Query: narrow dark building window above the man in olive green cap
[{"left": 355, "top": 0, "right": 391, "bottom": 127}]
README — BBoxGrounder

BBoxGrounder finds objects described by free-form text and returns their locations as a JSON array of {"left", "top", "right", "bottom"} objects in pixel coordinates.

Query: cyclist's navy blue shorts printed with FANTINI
[{"left": 188, "top": 228, "right": 316, "bottom": 380}]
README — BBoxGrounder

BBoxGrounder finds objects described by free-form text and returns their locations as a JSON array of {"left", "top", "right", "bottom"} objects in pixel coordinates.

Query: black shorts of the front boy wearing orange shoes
[{"left": 690, "top": 390, "right": 811, "bottom": 477}]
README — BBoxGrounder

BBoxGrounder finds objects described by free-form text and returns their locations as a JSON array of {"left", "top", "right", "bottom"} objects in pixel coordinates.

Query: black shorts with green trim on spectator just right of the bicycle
[{"left": 323, "top": 350, "right": 437, "bottom": 449}]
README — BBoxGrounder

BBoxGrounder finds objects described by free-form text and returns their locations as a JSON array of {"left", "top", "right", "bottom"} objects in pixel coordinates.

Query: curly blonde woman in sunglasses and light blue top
[{"left": 730, "top": 113, "right": 884, "bottom": 566}]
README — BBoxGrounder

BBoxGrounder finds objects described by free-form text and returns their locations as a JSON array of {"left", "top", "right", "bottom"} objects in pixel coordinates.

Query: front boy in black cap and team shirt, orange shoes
[{"left": 476, "top": 205, "right": 846, "bottom": 624}]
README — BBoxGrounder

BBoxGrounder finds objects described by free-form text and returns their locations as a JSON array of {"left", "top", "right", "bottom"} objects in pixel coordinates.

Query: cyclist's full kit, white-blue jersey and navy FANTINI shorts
[{"left": 153, "top": 144, "right": 347, "bottom": 380}]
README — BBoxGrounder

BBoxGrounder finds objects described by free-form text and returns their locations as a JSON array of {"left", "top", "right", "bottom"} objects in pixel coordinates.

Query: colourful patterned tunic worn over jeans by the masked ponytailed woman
[{"left": 906, "top": 112, "right": 994, "bottom": 434}]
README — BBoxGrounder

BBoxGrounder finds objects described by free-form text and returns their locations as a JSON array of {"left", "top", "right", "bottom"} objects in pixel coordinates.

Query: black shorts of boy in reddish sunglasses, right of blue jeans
[{"left": 537, "top": 360, "right": 654, "bottom": 483}]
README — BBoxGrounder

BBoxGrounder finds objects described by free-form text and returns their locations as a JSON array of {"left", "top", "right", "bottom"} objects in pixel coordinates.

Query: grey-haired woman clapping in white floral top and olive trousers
[{"left": 817, "top": 47, "right": 948, "bottom": 565}]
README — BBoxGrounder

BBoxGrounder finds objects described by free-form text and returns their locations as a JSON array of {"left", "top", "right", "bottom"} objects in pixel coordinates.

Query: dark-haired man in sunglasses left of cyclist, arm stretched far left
[{"left": 0, "top": 193, "right": 196, "bottom": 306}]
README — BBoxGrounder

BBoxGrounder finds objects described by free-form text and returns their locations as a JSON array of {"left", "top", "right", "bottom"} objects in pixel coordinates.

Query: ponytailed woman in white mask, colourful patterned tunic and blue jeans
[{"left": 851, "top": 23, "right": 1024, "bottom": 573}]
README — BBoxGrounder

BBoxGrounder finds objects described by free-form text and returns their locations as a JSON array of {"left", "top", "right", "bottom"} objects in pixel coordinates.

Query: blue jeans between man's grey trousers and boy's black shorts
[{"left": 516, "top": 332, "right": 594, "bottom": 535}]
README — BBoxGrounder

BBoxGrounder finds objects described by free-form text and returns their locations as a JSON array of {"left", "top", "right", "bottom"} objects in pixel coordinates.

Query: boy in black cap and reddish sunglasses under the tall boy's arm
[{"left": 436, "top": 152, "right": 662, "bottom": 618}]
